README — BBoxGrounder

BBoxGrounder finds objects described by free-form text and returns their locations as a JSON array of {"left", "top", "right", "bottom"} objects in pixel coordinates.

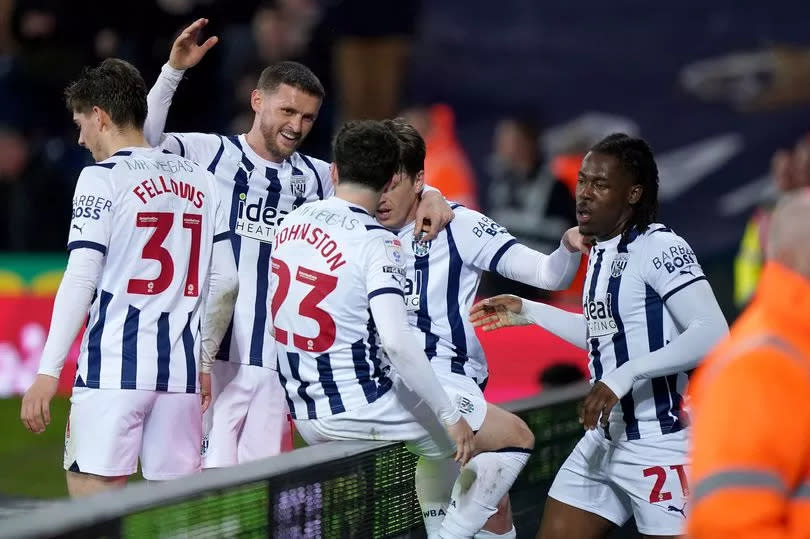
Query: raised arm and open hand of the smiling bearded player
[{"left": 144, "top": 19, "right": 219, "bottom": 146}]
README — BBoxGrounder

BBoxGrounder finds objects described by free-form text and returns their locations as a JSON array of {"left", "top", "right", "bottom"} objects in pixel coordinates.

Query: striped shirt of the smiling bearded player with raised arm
[{"left": 161, "top": 133, "right": 334, "bottom": 368}]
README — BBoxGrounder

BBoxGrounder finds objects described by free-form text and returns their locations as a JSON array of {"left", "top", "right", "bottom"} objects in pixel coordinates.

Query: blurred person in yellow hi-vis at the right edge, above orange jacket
[{"left": 734, "top": 136, "right": 810, "bottom": 308}]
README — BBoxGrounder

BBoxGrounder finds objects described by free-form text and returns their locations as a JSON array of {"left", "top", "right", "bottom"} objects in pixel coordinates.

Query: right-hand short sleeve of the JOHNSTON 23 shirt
[{"left": 365, "top": 232, "right": 405, "bottom": 299}]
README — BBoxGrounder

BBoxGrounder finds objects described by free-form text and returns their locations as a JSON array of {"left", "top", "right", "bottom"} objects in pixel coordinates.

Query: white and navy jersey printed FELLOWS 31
[{"left": 68, "top": 148, "right": 229, "bottom": 393}]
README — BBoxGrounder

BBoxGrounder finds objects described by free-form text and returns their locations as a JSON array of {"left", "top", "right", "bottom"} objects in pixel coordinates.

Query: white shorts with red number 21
[{"left": 548, "top": 430, "right": 689, "bottom": 535}]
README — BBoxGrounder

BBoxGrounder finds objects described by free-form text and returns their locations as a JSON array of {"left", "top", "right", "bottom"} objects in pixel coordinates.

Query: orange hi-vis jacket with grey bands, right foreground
[{"left": 688, "top": 262, "right": 810, "bottom": 539}]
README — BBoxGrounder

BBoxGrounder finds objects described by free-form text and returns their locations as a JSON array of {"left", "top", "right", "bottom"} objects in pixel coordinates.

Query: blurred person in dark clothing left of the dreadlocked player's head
[{"left": 487, "top": 118, "right": 579, "bottom": 253}]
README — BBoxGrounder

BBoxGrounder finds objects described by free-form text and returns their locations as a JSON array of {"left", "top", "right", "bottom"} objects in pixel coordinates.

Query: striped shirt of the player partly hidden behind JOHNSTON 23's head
[{"left": 398, "top": 204, "right": 517, "bottom": 383}]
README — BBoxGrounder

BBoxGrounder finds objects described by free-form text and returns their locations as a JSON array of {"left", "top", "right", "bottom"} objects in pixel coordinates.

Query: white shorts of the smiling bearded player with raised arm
[{"left": 202, "top": 361, "right": 292, "bottom": 468}]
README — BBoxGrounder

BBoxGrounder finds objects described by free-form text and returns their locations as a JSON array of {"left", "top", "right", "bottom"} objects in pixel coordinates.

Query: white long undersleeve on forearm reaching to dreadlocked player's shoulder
[{"left": 496, "top": 242, "right": 580, "bottom": 290}]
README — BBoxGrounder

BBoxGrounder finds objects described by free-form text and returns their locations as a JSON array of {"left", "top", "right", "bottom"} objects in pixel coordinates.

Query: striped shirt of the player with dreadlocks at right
[{"left": 583, "top": 224, "right": 706, "bottom": 440}]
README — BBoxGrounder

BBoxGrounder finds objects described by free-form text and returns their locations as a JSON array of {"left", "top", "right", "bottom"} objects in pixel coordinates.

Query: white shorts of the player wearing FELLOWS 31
[{"left": 64, "top": 387, "right": 202, "bottom": 481}]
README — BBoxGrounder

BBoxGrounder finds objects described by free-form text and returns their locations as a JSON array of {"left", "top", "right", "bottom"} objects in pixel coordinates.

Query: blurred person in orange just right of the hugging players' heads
[{"left": 402, "top": 104, "right": 479, "bottom": 209}]
